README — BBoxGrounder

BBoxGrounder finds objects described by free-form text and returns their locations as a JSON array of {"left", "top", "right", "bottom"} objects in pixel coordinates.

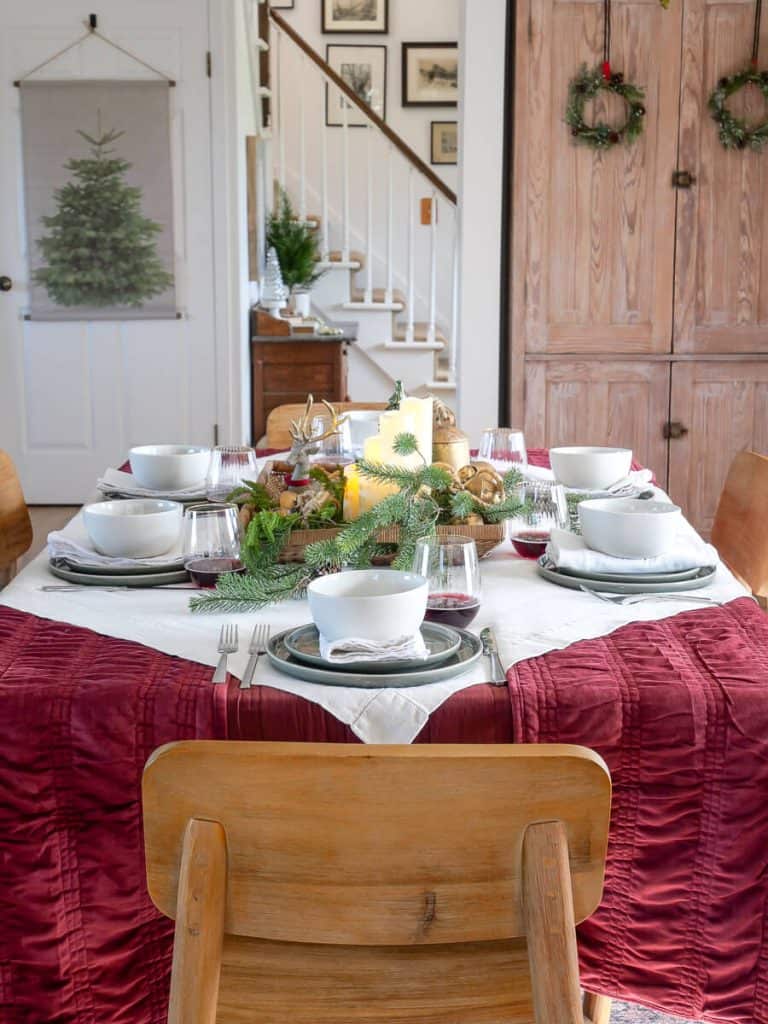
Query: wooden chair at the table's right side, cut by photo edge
[{"left": 712, "top": 452, "right": 768, "bottom": 603}]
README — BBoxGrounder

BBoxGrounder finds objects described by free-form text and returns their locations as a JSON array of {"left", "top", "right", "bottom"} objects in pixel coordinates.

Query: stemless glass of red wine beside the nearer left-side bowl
[{"left": 183, "top": 502, "right": 244, "bottom": 587}]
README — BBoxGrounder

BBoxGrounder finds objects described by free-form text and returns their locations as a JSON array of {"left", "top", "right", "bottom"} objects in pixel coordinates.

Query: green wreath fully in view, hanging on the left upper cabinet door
[{"left": 565, "top": 65, "right": 645, "bottom": 150}]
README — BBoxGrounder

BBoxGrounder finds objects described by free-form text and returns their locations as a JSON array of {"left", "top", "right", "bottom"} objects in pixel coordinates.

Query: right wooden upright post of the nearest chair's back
[{"left": 522, "top": 821, "right": 584, "bottom": 1024}]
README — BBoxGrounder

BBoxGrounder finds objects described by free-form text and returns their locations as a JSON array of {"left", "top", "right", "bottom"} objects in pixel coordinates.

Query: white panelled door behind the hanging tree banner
[{"left": 0, "top": 0, "right": 216, "bottom": 504}]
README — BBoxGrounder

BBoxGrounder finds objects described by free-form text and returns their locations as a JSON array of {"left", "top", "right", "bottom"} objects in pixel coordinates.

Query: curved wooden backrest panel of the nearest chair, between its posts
[{"left": 143, "top": 740, "right": 610, "bottom": 946}]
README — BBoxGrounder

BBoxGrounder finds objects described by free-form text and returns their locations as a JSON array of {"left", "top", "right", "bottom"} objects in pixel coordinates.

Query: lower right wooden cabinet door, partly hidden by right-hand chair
[{"left": 670, "top": 359, "right": 768, "bottom": 537}]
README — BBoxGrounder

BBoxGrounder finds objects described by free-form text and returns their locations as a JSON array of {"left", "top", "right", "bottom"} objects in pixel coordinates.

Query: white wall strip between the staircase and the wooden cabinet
[{"left": 458, "top": 0, "right": 507, "bottom": 441}]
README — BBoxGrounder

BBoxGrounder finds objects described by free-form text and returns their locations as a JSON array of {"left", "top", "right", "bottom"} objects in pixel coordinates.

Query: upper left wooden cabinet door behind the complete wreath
[{"left": 512, "top": 0, "right": 682, "bottom": 358}]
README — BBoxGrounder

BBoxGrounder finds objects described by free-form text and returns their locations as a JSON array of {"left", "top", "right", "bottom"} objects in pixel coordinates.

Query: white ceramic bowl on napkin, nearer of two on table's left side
[{"left": 83, "top": 498, "right": 184, "bottom": 558}]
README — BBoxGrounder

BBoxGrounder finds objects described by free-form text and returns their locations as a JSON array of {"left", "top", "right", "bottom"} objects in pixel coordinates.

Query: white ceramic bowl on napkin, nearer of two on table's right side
[{"left": 579, "top": 498, "right": 681, "bottom": 558}]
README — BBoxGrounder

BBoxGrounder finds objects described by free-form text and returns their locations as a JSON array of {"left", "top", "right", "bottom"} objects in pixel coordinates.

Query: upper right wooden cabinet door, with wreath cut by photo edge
[{"left": 674, "top": 0, "right": 768, "bottom": 353}]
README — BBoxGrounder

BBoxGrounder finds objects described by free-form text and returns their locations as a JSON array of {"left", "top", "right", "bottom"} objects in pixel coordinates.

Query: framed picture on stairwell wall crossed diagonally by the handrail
[{"left": 326, "top": 43, "right": 387, "bottom": 128}]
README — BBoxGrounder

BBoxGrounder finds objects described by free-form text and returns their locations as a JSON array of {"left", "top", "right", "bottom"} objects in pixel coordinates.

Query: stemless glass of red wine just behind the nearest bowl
[{"left": 414, "top": 536, "right": 480, "bottom": 627}]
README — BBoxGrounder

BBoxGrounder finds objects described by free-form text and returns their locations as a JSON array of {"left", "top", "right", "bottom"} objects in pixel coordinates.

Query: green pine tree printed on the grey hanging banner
[{"left": 33, "top": 117, "right": 173, "bottom": 308}]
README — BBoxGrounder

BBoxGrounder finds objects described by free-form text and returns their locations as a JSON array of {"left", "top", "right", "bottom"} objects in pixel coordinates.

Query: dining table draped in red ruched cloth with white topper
[{"left": 0, "top": 450, "right": 768, "bottom": 1024}]
